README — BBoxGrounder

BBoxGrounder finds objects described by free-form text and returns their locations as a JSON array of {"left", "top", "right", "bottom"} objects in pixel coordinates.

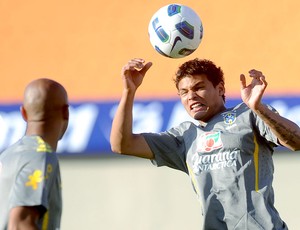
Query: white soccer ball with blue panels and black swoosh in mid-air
[{"left": 148, "top": 4, "right": 203, "bottom": 58}]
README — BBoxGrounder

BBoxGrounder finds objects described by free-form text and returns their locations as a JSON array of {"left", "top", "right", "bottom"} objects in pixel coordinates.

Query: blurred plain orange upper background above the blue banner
[{"left": 0, "top": 0, "right": 300, "bottom": 103}]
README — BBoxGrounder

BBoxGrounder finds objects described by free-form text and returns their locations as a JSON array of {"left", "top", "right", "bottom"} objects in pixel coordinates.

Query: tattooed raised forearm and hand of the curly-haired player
[{"left": 240, "top": 70, "right": 300, "bottom": 151}]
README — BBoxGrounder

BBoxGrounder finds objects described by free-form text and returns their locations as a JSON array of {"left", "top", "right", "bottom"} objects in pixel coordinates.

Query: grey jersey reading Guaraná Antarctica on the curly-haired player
[{"left": 143, "top": 103, "right": 287, "bottom": 230}]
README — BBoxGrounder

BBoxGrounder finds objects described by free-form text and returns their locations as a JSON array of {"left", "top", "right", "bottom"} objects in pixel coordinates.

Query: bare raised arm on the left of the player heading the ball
[{"left": 110, "top": 58, "right": 153, "bottom": 159}]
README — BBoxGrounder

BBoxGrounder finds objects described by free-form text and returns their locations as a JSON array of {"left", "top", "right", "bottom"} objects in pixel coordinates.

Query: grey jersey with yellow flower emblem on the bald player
[{"left": 0, "top": 136, "right": 62, "bottom": 230}]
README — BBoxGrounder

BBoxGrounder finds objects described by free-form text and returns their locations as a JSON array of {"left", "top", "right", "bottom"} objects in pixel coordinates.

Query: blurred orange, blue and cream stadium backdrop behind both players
[{"left": 0, "top": 0, "right": 300, "bottom": 230}]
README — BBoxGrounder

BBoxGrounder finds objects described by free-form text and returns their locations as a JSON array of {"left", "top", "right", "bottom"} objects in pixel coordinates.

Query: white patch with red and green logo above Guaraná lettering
[{"left": 197, "top": 132, "right": 223, "bottom": 152}]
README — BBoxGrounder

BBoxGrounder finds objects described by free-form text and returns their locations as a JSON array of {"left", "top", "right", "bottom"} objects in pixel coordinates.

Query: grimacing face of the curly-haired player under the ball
[{"left": 178, "top": 74, "right": 225, "bottom": 122}]
